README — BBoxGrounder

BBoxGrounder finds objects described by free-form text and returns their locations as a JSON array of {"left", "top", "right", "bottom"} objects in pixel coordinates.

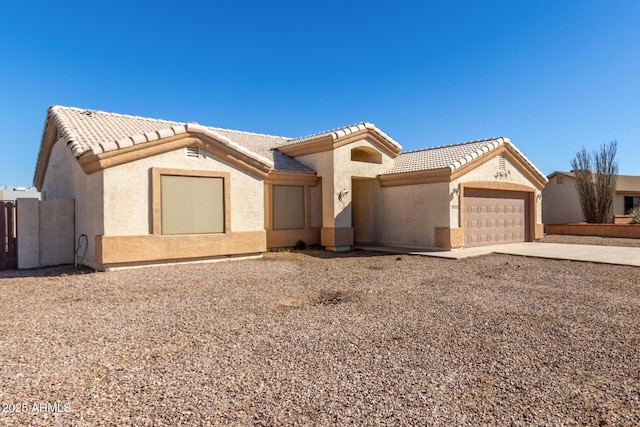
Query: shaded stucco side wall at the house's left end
[{"left": 42, "top": 140, "right": 104, "bottom": 268}]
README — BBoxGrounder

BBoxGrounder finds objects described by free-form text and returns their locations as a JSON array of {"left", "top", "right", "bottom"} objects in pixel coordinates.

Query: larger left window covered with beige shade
[{"left": 160, "top": 175, "right": 225, "bottom": 234}]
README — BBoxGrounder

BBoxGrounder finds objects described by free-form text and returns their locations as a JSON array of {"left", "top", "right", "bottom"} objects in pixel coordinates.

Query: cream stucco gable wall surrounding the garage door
[{"left": 449, "top": 155, "right": 542, "bottom": 228}]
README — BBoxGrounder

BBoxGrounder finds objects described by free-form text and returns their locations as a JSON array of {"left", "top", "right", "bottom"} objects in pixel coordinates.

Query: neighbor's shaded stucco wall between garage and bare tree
[{"left": 542, "top": 175, "right": 584, "bottom": 224}]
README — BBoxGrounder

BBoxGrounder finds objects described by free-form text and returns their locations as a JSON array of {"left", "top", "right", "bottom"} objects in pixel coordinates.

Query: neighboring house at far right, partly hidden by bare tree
[{"left": 542, "top": 171, "right": 640, "bottom": 224}]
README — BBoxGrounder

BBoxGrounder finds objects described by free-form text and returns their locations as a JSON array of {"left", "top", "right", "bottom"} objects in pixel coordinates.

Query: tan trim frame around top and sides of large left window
[{"left": 151, "top": 168, "right": 232, "bottom": 235}]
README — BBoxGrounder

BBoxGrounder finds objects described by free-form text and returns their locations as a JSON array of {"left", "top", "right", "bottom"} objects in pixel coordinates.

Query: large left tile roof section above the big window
[{"left": 50, "top": 106, "right": 313, "bottom": 172}]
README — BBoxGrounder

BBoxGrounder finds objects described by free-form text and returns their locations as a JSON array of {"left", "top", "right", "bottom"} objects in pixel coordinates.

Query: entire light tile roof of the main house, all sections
[{"left": 39, "top": 106, "right": 544, "bottom": 182}]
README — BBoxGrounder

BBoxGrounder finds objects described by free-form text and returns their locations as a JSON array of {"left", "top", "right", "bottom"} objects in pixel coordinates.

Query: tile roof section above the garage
[{"left": 382, "top": 137, "right": 544, "bottom": 177}]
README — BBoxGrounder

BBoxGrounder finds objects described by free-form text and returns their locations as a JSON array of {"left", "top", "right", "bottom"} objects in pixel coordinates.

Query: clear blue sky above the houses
[{"left": 0, "top": 0, "right": 640, "bottom": 185}]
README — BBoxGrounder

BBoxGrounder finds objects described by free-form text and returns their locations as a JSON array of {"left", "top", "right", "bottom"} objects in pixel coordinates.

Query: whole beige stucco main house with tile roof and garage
[{"left": 34, "top": 106, "right": 547, "bottom": 269}]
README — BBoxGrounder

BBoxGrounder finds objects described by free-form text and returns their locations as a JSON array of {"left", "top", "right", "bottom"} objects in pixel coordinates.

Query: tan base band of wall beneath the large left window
[{"left": 95, "top": 231, "right": 267, "bottom": 266}]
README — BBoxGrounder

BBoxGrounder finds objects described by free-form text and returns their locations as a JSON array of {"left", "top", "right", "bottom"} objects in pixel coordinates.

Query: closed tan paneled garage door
[{"left": 463, "top": 188, "right": 530, "bottom": 247}]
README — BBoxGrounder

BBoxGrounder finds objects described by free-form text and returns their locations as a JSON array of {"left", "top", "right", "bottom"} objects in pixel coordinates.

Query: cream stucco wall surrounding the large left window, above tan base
[{"left": 103, "top": 148, "right": 264, "bottom": 236}]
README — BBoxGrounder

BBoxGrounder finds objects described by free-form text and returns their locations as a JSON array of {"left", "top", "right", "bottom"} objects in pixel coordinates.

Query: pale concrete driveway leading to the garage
[{"left": 360, "top": 242, "right": 640, "bottom": 267}]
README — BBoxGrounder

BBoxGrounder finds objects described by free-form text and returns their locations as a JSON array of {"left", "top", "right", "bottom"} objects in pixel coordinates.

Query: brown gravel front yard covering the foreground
[{"left": 0, "top": 251, "right": 640, "bottom": 426}]
